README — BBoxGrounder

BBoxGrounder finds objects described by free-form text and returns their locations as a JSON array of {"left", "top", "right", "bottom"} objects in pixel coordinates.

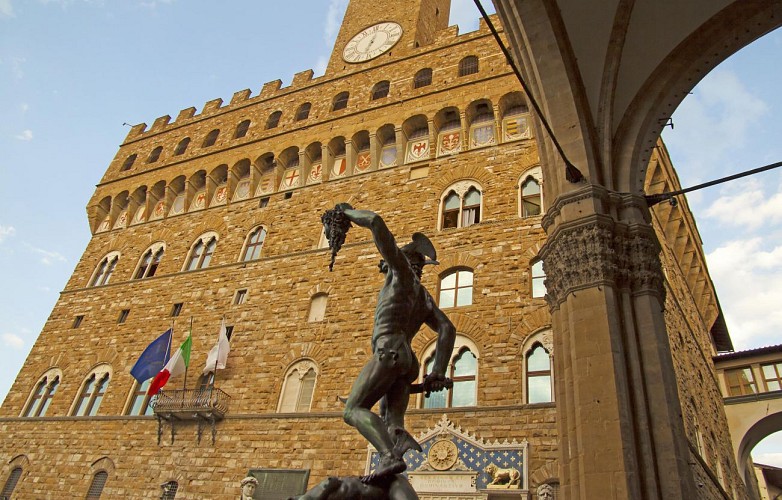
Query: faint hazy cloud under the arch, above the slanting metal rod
[{"left": 664, "top": 68, "right": 770, "bottom": 184}]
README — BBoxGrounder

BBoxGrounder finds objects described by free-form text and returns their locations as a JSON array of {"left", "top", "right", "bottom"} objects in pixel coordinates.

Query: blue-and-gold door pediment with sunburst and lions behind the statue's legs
[{"left": 364, "top": 414, "right": 529, "bottom": 499}]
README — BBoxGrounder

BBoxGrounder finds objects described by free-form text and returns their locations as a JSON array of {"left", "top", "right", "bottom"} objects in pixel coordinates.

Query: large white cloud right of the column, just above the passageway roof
[{"left": 706, "top": 235, "right": 782, "bottom": 350}]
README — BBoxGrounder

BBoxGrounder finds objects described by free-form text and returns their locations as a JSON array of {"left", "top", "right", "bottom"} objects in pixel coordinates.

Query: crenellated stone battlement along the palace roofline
[{"left": 123, "top": 14, "right": 501, "bottom": 144}]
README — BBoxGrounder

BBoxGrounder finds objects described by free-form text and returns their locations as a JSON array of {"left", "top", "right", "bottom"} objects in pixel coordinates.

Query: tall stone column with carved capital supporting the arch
[{"left": 541, "top": 185, "right": 697, "bottom": 500}]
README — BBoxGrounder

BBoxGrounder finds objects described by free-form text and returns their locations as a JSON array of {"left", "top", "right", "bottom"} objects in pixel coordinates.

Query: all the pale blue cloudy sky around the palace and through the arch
[{"left": 0, "top": 0, "right": 782, "bottom": 467}]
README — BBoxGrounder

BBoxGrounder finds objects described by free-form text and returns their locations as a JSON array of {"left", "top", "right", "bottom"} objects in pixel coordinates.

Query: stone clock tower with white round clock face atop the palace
[{"left": 326, "top": 0, "right": 451, "bottom": 74}]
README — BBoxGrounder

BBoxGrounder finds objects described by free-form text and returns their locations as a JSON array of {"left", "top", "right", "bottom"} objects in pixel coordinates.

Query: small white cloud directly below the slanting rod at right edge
[{"left": 703, "top": 178, "right": 782, "bottom": 231}]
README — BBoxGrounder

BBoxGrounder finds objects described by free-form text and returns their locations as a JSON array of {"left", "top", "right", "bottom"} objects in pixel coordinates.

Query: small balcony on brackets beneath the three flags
[{"left": 151, "top": 386, "right": 231, "bottom": 444}]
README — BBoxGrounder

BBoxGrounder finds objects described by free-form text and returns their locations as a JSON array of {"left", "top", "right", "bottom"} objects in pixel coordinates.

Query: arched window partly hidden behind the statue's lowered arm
[{"left": 421, "top": 335, "right": 478, "bottom": 408}]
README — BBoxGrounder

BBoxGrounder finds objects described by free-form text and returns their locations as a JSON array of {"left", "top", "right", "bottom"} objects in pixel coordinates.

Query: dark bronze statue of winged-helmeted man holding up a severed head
[{"left": 322, "top": 203, "right": 456, "bottom": 483}]
